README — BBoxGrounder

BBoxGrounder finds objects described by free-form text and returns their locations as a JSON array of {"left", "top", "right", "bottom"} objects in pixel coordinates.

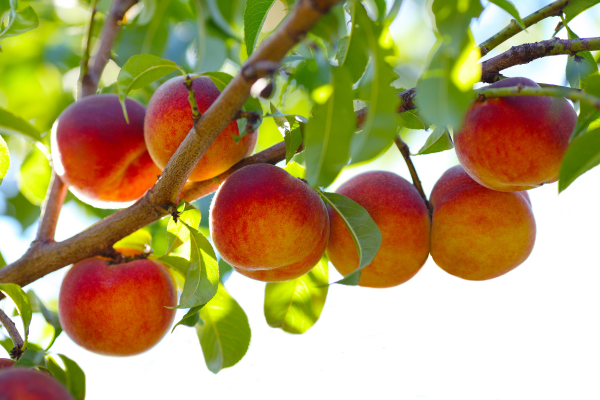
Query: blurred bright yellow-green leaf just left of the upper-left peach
[{"left": 19, "top": 146, "right": 52, "bottom": 206}]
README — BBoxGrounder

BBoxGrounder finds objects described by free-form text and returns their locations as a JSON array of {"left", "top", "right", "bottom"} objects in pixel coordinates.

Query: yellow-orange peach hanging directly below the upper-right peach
[{"left": 430, "top": 165, "right": 535, "bottom": 281}]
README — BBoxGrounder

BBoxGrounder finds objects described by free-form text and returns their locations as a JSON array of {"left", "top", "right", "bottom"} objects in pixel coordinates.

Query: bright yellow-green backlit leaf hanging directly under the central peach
[{"left": 264, "top": 258, "right": 329, "bottom": 333}]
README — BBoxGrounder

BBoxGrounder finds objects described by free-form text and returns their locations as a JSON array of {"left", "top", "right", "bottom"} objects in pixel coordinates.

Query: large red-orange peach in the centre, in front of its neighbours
[{"left": 210, "top": 164, "right": 329, "bottom": 282}]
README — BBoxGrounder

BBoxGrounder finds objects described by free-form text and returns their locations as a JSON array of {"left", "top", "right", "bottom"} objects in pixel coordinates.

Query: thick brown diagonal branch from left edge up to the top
[{"left": 0, "top": 0, "right": 340, "bottom": 292}]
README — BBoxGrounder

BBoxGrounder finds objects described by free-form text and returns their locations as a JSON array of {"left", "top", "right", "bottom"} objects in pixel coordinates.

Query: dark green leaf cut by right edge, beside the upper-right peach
[{"left": 558, "top": 128, "right": 600, "bottom": 193}]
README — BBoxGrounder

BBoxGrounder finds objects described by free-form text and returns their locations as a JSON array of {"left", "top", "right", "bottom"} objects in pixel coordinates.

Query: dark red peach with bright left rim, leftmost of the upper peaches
[{"left": 52, "top": 94, "right": 160, "bottom": 208}]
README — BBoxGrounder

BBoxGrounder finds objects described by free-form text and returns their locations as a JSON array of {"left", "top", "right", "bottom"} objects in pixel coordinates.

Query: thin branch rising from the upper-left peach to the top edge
[{"left": 81, "top": 0, "right": 138, "bottom": 97}]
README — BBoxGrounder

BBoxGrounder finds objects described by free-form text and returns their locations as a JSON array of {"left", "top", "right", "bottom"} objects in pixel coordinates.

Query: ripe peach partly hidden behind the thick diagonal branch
[{"left": 144, "top": 76, "right": 258, "bottom": 181}]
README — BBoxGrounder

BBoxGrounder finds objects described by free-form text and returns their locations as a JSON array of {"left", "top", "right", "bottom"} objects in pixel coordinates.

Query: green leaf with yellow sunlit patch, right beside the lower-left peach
[{"left": 175, "top": 222, "right": 219, "bottom": 308}]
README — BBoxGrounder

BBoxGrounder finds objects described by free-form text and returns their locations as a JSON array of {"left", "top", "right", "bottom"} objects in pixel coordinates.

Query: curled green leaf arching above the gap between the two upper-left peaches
[{"left": 117, "top": 54, "right": 184, "bottom": 123}]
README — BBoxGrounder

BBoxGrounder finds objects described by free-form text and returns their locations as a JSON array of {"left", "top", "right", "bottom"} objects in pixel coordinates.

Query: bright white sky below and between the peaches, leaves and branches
[{"left": 0, "top": 0, "right": 600, "bottom": 400}]
